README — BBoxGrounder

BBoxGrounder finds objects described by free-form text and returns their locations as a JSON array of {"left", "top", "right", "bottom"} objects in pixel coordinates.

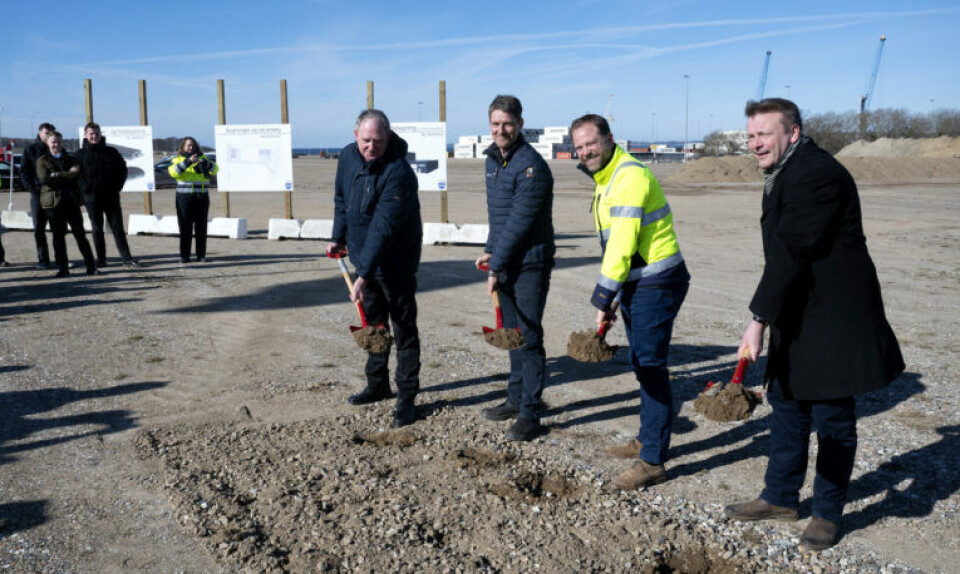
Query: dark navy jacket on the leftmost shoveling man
[{"left": 332, "top": 132, "right": 423, "bottom": 279}]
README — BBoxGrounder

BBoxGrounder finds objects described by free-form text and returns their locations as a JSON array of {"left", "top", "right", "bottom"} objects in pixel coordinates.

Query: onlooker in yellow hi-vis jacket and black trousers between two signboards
[{"left": 167, "top": 137, "right": 220, "bottom": 263}]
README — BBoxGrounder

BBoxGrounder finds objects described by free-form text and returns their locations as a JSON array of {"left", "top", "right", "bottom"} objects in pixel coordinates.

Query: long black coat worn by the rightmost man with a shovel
[{"left": 750, "top": 140, "right": 904, "bottom": 400}]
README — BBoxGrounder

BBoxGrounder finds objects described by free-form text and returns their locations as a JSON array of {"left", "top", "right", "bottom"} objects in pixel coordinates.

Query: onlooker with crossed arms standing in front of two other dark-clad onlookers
[{"left": 36, "top": 131, "right": 100, "bottom": 277}]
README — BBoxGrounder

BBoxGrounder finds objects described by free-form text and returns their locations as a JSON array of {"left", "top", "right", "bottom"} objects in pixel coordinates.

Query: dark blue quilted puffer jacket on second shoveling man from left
[{"left": 483, "top": 135, "right": 557, "bottom": 276}]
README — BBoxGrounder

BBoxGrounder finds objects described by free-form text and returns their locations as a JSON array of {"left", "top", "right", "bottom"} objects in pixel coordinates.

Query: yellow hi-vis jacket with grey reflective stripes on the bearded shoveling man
[{"left": 593, "top": 146, "right": 683, "bottom": 291}]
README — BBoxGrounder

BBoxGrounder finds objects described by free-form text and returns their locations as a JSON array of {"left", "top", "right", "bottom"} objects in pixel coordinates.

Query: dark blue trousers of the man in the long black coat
[{"left": 760, "top": 381, "right": 857, "bottom": 523}]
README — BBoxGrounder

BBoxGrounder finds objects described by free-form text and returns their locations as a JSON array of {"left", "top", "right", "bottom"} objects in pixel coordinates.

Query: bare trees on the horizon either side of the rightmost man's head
[{"left": 703, "top": 108, "right": 960, "bottom": 155}]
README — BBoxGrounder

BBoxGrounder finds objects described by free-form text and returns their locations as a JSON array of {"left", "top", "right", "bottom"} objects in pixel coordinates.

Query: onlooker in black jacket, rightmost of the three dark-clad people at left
[{"left": 77, "top": 122, "right": 140, "bottom": 267}]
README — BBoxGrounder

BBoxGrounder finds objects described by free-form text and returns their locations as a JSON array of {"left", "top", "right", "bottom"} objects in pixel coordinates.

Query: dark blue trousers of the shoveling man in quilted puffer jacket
[{"left": 498, "top": 266, "right": 552, "bottom": 419}]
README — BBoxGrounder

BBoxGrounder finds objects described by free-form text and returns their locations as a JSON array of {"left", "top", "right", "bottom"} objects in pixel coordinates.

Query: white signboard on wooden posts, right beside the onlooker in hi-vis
[{"left": 214, "top": 124, "right": 293, "bottom": 191}]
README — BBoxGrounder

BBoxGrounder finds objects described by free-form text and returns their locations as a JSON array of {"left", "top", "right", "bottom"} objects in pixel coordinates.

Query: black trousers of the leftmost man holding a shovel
[{"left": 363, "top": 275, "right": 420, "bottom": 397}]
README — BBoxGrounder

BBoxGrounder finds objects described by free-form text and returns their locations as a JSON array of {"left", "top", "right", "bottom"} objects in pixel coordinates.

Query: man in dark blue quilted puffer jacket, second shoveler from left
[{"left": 476, "top": 96, "right": 556, "bottom": 441}]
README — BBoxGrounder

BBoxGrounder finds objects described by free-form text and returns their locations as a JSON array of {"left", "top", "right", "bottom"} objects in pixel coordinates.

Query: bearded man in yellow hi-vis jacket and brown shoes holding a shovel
[{"left": 570, "top": 114, "right": 690, "bottom": 490}]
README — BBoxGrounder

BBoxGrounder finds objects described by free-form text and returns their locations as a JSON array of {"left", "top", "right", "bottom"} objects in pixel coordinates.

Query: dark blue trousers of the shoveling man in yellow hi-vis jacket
[{"left": 620, "top": 283, "right": 690, "bottom": 464}]
